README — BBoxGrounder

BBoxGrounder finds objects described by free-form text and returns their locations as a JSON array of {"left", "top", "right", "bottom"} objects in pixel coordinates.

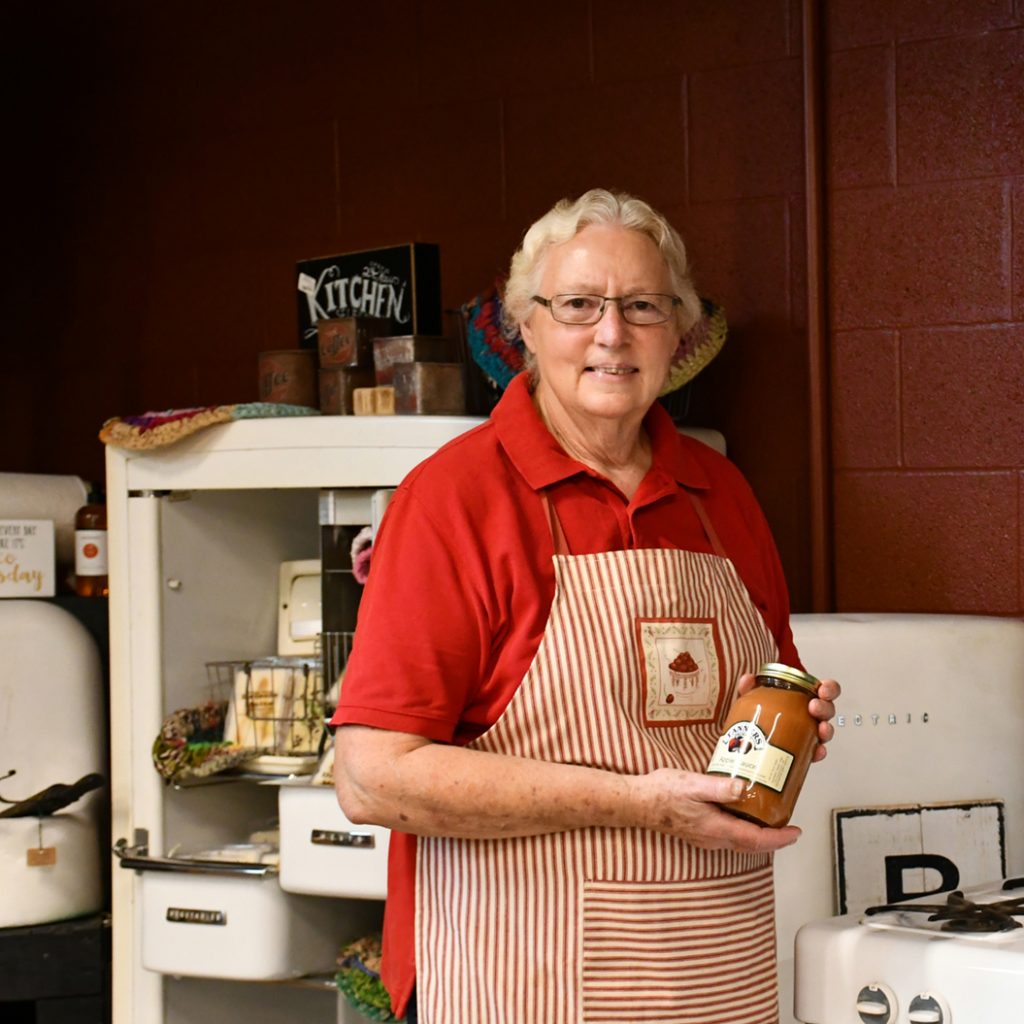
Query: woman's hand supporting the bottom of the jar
[{"left": 633, "top": 768, "right": 800, "bottom": 853}]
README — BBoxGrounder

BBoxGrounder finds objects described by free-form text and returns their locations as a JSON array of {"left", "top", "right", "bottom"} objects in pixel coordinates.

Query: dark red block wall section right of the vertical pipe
[{"left": 827, "top": 0, "right": 1024, "bottom": 614}]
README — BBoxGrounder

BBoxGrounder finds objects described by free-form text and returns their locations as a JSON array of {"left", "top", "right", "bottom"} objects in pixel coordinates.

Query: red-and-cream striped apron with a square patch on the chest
[{"left": 416, "top": 496, "right": 778, "bottom": 1024}]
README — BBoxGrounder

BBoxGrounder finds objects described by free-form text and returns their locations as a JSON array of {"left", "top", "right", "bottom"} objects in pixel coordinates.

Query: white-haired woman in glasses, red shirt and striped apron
[{"left": 335, "top": 190, "right": 839, "bottom": 1024}]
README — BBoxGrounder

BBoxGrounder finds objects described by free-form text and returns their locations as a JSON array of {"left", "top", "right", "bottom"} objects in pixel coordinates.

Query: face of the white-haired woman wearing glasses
[{"left": 520, "top": 224, "right": 679, "bottom": 423}]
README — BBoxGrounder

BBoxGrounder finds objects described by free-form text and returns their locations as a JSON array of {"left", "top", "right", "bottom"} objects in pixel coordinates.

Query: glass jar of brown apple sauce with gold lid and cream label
[{"left": 708, "top": 662, "right": 819, "bottom": 828}]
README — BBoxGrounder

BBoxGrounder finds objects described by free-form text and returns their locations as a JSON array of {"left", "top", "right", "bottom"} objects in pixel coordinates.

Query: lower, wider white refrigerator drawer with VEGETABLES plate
[{"left": 139, "top": 871, "right": 381, "bottom": 981}]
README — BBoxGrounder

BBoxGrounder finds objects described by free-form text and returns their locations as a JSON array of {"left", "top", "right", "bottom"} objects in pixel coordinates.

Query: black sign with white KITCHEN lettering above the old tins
[{"left": 296, "top": 242, "right": 441, "bottom": 348}]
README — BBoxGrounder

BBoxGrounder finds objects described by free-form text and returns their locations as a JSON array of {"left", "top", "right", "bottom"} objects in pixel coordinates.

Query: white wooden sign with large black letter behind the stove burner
[{"left": 833, "top": 800, "right": 1007, "bottom": 913}]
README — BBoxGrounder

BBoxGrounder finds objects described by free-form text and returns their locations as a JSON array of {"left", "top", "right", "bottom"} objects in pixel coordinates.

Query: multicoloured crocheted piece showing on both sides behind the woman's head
[{"left": 462, "top": 279, "right": 728, "bottom": 395}]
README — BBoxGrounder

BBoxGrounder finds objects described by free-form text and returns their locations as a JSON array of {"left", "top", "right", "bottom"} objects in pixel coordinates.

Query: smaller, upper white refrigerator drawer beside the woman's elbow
[{"left": 278, "top": 785, "right": 391, "bottom": 899}]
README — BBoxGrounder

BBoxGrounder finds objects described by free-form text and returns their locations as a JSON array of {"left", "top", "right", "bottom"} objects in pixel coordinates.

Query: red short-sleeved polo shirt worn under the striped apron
[{"left": 333, "top": 375, "right": 801, "bottom": 1016}]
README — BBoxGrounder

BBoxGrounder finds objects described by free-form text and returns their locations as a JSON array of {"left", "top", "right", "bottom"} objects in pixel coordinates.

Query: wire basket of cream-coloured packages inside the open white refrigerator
[{"left": 206, "top": 656, "right": 326, "bottom": 758}]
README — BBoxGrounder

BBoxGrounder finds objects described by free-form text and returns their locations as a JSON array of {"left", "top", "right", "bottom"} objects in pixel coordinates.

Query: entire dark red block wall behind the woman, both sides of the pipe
[{"left": 0, "top": 0, "right": 1024, "bottom": 614}]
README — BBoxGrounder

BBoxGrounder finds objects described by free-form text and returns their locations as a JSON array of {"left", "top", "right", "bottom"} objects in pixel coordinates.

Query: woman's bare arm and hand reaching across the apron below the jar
[{"left": 335, "top": 725, "right": 800, "bottom": 852}]
